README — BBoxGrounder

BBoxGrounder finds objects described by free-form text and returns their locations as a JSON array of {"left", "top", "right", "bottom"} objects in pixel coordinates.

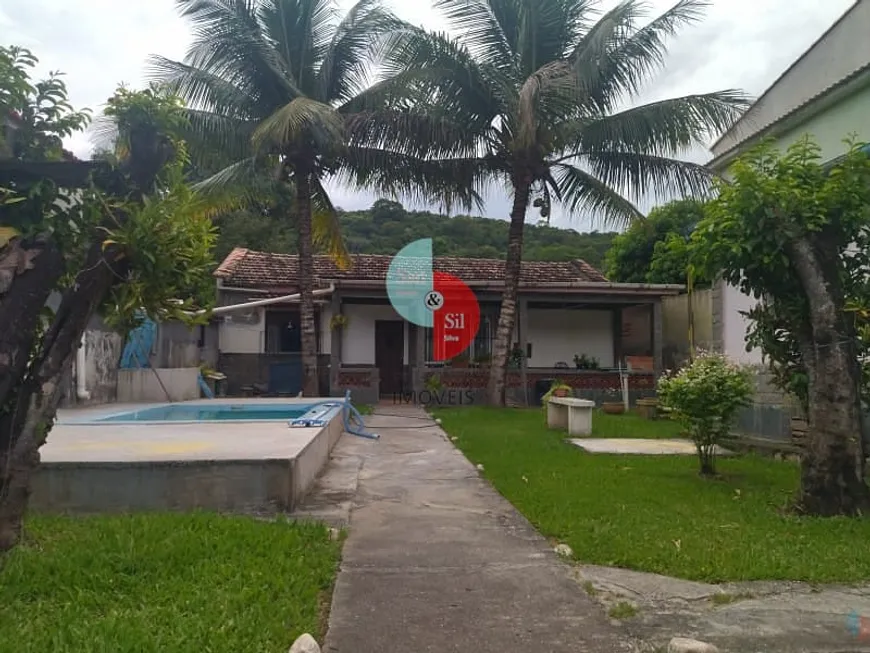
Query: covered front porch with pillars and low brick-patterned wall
[{"left": 321, "top": 289, "right": 663, "bottom": 405}]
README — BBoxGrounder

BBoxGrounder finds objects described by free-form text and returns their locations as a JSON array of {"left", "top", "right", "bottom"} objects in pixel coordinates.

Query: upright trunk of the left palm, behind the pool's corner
[{"left": 296, "top": 168, "right": 318, "bottom": 397}]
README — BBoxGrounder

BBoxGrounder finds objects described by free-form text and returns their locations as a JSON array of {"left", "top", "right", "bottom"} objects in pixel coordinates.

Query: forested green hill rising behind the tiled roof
[{"left": 217, "top": 200, "right": 616, "bottom": 269}]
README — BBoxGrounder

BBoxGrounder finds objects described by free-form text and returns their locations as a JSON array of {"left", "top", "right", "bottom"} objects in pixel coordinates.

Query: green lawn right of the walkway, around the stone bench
[{"left": 437, "top": 407, "right": 870, "bottom": 582}]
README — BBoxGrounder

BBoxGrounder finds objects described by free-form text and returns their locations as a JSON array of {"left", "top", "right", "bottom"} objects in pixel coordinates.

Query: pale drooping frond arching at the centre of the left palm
[{"left": 251, "top": 97, "right": 345, "bottom": 152}]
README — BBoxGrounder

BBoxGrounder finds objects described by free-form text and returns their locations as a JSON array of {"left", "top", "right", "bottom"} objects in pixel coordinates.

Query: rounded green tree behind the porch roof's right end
[{"left": 606, "top": 199, "right": 704, "bottom": 284}]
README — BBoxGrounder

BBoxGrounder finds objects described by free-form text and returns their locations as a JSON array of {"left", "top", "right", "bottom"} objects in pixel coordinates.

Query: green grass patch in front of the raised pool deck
[{"left": 0, "top": 513, "right": 341, "bottom": 653}]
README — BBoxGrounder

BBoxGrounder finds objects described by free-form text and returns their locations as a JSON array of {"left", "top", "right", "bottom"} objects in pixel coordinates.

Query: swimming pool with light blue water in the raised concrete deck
[{"left": 91, "top": 402, "right": 341, "bottom": 426}]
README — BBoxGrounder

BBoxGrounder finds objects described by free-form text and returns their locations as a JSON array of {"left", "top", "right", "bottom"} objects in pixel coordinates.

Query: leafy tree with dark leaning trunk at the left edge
[{"left": 0, "top": 48, "right": 214, "bottom": 552}]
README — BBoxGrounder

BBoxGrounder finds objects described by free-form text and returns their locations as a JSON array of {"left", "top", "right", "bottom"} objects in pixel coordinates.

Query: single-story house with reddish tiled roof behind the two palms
[{"left": 215, "top": 249, "right": 682, "bottom": 403}]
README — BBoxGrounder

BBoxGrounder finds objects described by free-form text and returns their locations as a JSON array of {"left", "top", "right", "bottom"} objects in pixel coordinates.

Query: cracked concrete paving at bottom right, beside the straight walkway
[{"left": 576, "top": 553, "right": 870, "bottom": 653}]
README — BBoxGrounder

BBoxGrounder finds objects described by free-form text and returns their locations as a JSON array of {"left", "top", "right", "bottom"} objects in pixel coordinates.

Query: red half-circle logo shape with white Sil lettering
[{"left": 426, "top": 272, "right": 480, "bottom": 361}]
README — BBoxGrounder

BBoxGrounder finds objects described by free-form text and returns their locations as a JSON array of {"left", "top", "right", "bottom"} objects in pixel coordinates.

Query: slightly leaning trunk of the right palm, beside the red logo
[{"left": 487, "top": 178, "right": 531, "bottom": 406}]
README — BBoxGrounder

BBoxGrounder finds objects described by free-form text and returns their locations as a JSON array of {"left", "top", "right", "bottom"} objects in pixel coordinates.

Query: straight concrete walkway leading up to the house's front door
[{"left": 301, "top": 406, "right": 632, "bottom": 653}]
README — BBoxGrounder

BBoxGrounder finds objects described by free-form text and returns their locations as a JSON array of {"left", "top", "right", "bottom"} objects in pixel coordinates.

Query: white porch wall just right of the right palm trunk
[{"left": 527, "top": 309, "right": 614, "bottom": 367}]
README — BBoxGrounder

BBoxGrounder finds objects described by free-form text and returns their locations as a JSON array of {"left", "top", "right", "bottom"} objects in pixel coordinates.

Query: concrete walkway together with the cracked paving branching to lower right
[{"left": 300, "top": 406, "right": 870, "bottom": 653}]
